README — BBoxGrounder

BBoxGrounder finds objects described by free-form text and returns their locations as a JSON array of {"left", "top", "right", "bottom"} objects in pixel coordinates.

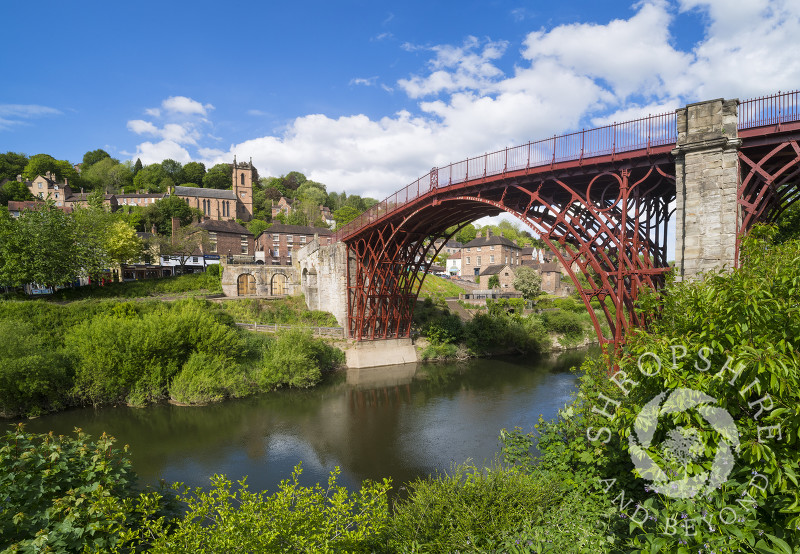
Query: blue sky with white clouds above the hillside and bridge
[{"left": 0, "top": 0, "right": 800, "bottom": 203}]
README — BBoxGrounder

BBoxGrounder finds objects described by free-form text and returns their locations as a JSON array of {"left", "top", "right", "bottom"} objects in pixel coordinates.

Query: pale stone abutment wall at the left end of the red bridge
[{"left": 297, "top": 239, "right": 348, "bottom": 333}]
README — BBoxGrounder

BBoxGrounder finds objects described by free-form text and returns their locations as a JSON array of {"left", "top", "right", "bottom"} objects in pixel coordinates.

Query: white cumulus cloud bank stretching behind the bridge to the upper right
[{"left": 129, "top": 0, "right": 800, "bottom": 203}]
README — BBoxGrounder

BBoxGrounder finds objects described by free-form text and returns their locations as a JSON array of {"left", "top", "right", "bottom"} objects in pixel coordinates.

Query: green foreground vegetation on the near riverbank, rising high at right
[{"left": 0, "top": 231, "right": 800, "bottom": 554}]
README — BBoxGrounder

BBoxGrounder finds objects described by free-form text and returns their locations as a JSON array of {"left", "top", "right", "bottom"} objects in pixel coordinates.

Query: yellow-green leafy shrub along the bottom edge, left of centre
[{"left": 122, "top": 465, "right": 390, "bottom": 553}]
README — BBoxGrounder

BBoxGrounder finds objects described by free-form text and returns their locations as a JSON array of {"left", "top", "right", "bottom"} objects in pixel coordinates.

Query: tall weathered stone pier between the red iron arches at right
[{"left": 672, "top": 99, "right": 741, "bottom": 279}]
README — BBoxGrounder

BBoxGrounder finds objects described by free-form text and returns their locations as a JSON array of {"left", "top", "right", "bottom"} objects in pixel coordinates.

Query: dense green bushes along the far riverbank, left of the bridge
[{"left": 0, "top": 298, "right": 344, "bottom": 417}]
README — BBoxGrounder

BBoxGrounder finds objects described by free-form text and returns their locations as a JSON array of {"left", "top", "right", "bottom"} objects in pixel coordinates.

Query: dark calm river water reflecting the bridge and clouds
[{"left": 21, "top": 352, "right": 585, "bottom": 491}]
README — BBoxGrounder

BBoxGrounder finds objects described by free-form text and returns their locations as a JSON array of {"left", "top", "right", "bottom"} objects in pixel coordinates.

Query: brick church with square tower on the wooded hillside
[{"left": 173, "top": 157, "right": 258, "bottom": 221}]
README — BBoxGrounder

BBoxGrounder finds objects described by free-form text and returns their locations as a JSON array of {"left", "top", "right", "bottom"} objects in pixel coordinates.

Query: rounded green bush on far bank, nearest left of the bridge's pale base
[{"left": 254, "top": 329, "right": 344, "bottom": 390}]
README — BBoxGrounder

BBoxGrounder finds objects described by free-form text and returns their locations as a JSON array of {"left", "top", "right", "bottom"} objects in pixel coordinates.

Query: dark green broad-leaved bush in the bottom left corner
[{"left": 0, "top": 424, "right": 140, "bottom": 552}]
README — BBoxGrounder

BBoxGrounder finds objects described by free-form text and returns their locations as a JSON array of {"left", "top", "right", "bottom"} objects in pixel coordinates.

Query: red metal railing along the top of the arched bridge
[{"left": 332, "top": 91, "right": 800, "bottom": 242}]
